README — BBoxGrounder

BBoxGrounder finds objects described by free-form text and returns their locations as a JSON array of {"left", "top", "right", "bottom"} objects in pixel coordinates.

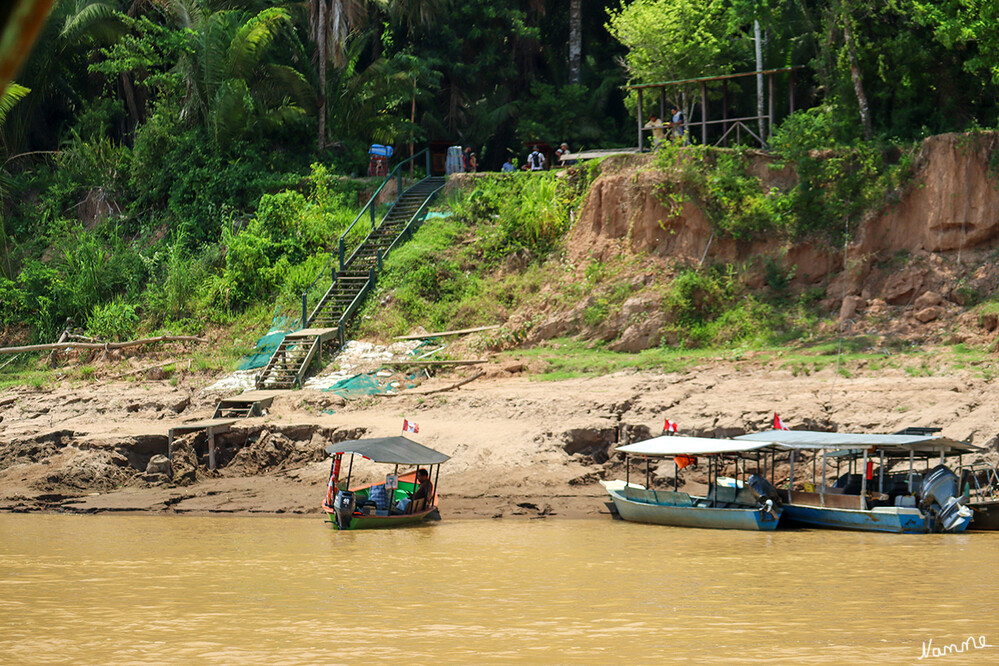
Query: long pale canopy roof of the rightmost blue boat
[{"left": 736, "top": 430, "right": 978, "bottom": 453}]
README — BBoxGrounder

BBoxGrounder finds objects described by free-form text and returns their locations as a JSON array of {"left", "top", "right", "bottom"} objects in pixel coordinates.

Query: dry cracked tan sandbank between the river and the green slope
[{"left": 0, "top": 348, "right": 999, "bottom": 517}]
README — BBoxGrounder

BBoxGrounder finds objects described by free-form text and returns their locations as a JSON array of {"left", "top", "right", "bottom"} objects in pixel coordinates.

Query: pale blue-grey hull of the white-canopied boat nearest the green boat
[{"left": 607, "top": 489, "right": 781, "bottom": 531}]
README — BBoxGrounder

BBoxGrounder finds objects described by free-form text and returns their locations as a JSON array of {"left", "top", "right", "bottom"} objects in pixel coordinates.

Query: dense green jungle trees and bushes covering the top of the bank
[{"left": 0, "top": 0, "right": 999, "bottom": 348}]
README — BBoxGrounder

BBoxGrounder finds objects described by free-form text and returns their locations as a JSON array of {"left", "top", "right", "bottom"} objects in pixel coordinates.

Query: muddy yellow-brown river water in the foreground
[{"left": 0, "top": 515, "right": 999, "bottom": 665}]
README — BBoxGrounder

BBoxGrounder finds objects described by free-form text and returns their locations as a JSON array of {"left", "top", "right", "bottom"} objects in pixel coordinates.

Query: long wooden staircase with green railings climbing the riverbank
[{"left": 257, "top": 172, "right": 445, "bottom": 389}]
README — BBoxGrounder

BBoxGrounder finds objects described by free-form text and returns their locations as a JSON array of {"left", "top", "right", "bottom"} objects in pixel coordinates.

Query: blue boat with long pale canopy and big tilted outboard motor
[{"left": 735, "top": 430, "right": 978, "bottom": 534}]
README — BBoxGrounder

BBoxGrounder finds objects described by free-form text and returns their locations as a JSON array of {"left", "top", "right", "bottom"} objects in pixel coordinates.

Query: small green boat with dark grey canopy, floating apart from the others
[{"left": 323, "top": 436, "right": 450, "bottom": 530}]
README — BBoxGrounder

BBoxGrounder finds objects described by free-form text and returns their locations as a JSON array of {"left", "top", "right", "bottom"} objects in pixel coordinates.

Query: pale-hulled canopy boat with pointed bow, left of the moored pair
[{"left": 601, "top": 436, "right": 783, "bottom": 530}]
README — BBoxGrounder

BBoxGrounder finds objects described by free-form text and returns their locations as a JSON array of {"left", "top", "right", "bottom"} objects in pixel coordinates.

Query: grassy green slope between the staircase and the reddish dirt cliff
[{"left": 360, "top": 173, "right": 586, "bottom": 337}]
